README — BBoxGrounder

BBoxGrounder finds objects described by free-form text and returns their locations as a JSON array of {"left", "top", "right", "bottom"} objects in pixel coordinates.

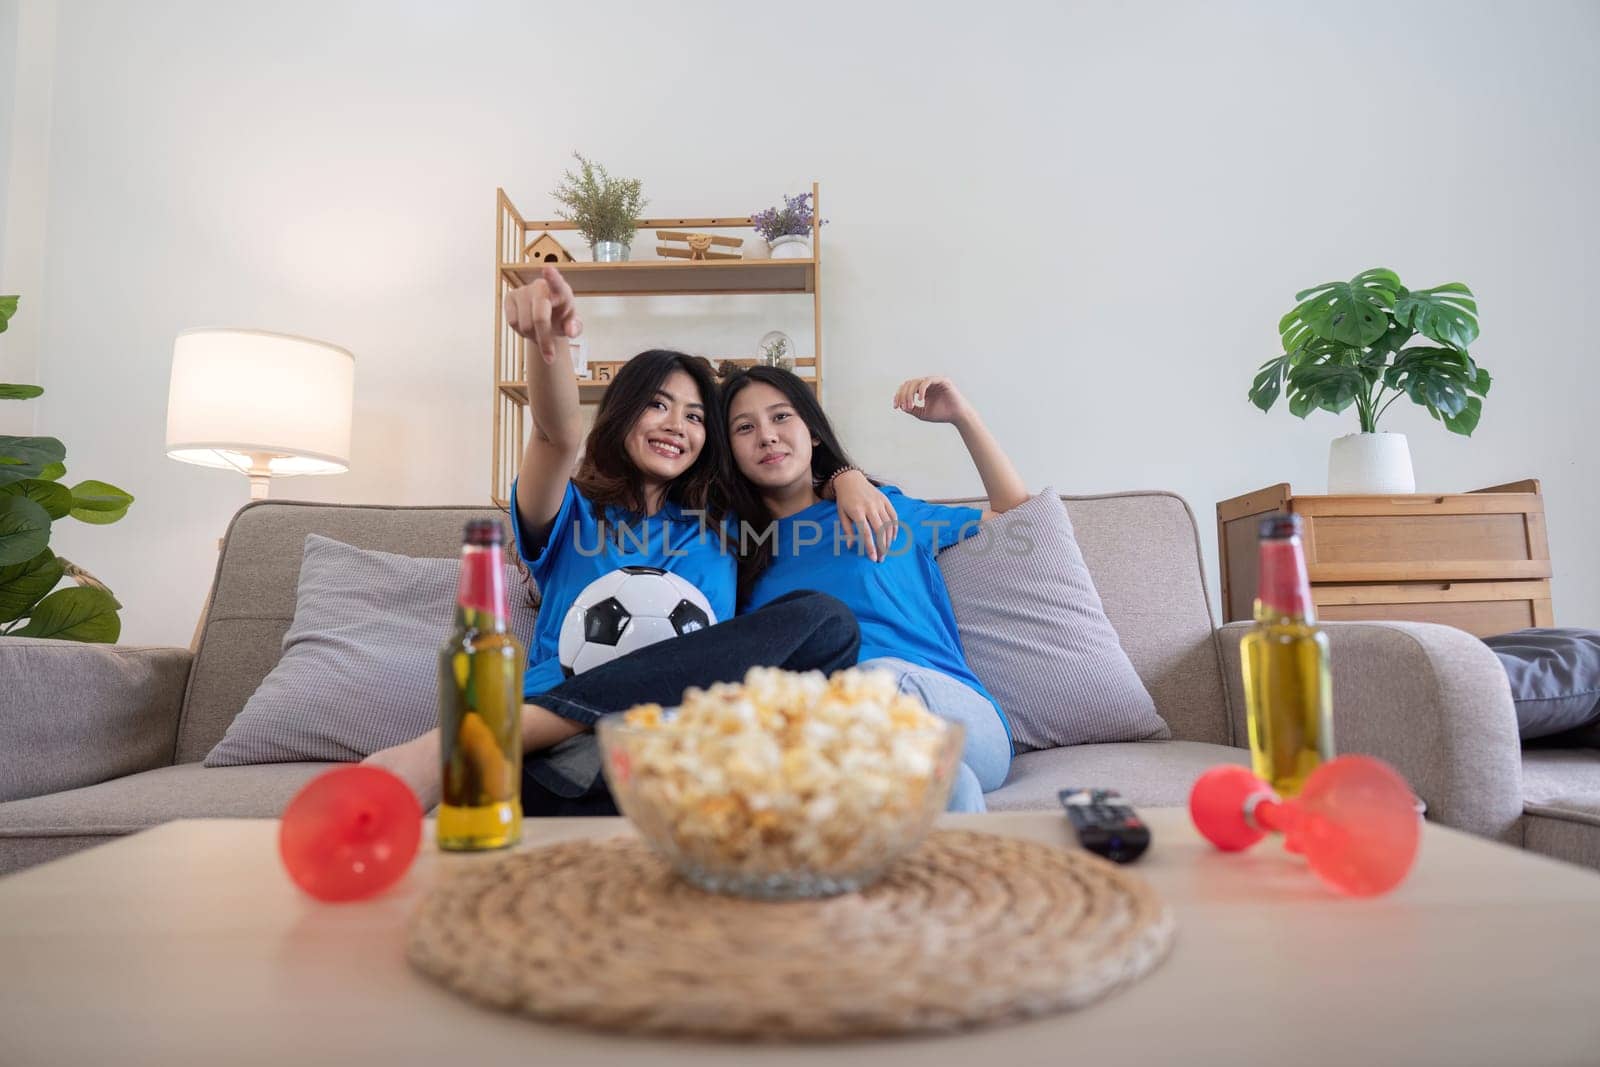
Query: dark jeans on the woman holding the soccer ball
[{"left": 522, "top": 590, "right": 861, "bottom": 816}]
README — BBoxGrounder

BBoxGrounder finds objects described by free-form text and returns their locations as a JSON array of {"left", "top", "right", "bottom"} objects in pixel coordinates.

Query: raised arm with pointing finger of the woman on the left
[{"left": 506, "top": 267, "right": 584, "bottom": 542}]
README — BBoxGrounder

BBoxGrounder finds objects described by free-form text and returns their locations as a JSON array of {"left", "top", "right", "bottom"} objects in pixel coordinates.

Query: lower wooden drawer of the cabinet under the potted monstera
[{"left": 1310, "top": 581, "right": 1554, "bottom": 637}]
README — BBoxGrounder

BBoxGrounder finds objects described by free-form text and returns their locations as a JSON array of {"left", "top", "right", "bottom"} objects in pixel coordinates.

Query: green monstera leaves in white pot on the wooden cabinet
[{"left": 1250, "top": 267, "right": 1490, "bottom": 437}]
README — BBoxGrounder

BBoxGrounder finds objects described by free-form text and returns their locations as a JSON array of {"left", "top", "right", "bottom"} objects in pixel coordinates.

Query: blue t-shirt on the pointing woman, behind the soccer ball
[{"left": 510, "top": 482, "right": 738, "bottom": 697}]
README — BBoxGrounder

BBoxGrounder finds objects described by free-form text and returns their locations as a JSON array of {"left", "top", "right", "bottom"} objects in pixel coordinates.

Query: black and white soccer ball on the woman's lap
[{"left": 558, "top": 566, "right": 717, "bottom": 678}]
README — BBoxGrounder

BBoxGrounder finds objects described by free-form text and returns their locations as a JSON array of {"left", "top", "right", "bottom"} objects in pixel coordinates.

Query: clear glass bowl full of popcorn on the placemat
[{"left": 598, "top": 667, "right": 962, "bottom": 899}]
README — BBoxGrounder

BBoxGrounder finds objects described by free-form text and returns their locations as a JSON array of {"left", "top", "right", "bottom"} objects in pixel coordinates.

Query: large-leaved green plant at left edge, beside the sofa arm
[{"left": 0, "top": 296, "right": 133, "bottom": 641}]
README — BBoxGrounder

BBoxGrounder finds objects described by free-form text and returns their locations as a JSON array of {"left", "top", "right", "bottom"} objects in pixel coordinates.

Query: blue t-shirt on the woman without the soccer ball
[{"left": 746, "top": 485, "right": 1011, "bottom": 734}]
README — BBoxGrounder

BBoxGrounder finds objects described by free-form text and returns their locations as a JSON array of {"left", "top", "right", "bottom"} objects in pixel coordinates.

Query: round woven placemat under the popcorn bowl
[{"left": 408, "top": 830, "right": 1174, "bottom": 1040}]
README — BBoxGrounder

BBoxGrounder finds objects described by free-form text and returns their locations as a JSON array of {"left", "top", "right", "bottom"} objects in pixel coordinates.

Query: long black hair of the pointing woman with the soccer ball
[{"left": 573, "top": 349, "right": 728, "bottom": 523}]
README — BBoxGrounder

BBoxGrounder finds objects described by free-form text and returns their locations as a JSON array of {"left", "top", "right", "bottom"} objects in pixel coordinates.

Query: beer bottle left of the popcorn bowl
[{"left": 438, "top": 518, "right": 528, "bottom": 851}]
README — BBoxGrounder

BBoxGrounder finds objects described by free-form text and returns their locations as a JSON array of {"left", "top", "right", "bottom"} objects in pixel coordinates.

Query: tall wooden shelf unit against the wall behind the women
[{"left": 490, "top": 182, "right": 822, "bottom": 507}]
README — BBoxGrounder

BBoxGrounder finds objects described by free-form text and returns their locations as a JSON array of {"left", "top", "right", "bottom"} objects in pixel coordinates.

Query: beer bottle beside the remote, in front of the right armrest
[{"left": 1240, "top": 514, "right": 1333, "bottom": 797}]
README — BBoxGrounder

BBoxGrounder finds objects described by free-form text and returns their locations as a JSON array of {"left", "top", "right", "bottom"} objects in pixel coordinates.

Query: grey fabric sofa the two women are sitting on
[{"left": 0, "top": 493, "right": 1600, "bottom": 872}]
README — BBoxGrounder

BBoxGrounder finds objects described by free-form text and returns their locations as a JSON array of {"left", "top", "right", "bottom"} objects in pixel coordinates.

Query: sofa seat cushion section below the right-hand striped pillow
[{"left": 984, "top": 741, "right": 1250, "bottom": 811}]
